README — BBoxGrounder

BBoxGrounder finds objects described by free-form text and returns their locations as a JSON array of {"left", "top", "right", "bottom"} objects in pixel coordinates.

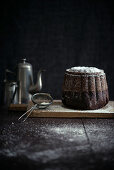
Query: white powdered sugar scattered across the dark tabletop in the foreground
[{"left": 0, "top": 119, "right": 89, "bottom": 164}]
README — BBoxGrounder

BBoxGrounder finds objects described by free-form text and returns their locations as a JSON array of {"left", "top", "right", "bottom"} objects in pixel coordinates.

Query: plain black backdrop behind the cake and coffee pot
[{"left": 0, "top": 0, "right": 114, "bottom": 103}]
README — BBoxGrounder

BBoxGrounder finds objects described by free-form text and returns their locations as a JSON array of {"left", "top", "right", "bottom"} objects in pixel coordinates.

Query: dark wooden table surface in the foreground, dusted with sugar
[{"left": 0, "top": 109, "right": 114, "bottom": 170}]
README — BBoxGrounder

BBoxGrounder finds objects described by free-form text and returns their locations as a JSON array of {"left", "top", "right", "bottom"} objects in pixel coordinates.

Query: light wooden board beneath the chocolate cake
[{"left": 27, "top": 100, "right": 114, "bottom": 118}]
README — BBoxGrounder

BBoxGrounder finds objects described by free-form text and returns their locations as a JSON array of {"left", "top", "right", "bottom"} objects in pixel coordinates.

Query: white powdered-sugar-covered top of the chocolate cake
[{"left": 66, "top": 66, "right": 104, "bottom": 74}]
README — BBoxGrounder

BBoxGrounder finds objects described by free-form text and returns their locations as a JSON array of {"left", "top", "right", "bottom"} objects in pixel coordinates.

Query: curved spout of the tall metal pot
[{"left": 29, "top": 69, "right": 45, "bottom": 94}]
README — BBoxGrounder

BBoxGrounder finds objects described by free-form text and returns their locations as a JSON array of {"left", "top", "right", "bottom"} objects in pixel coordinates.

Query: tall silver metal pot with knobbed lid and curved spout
[{"left": 17, "top": 59, "right": 44, "bottom": 103}]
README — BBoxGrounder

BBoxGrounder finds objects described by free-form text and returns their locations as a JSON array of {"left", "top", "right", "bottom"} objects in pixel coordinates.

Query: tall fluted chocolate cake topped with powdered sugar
[{"left": 62, "top": 67, "right": 109, "bottom": 110}]
